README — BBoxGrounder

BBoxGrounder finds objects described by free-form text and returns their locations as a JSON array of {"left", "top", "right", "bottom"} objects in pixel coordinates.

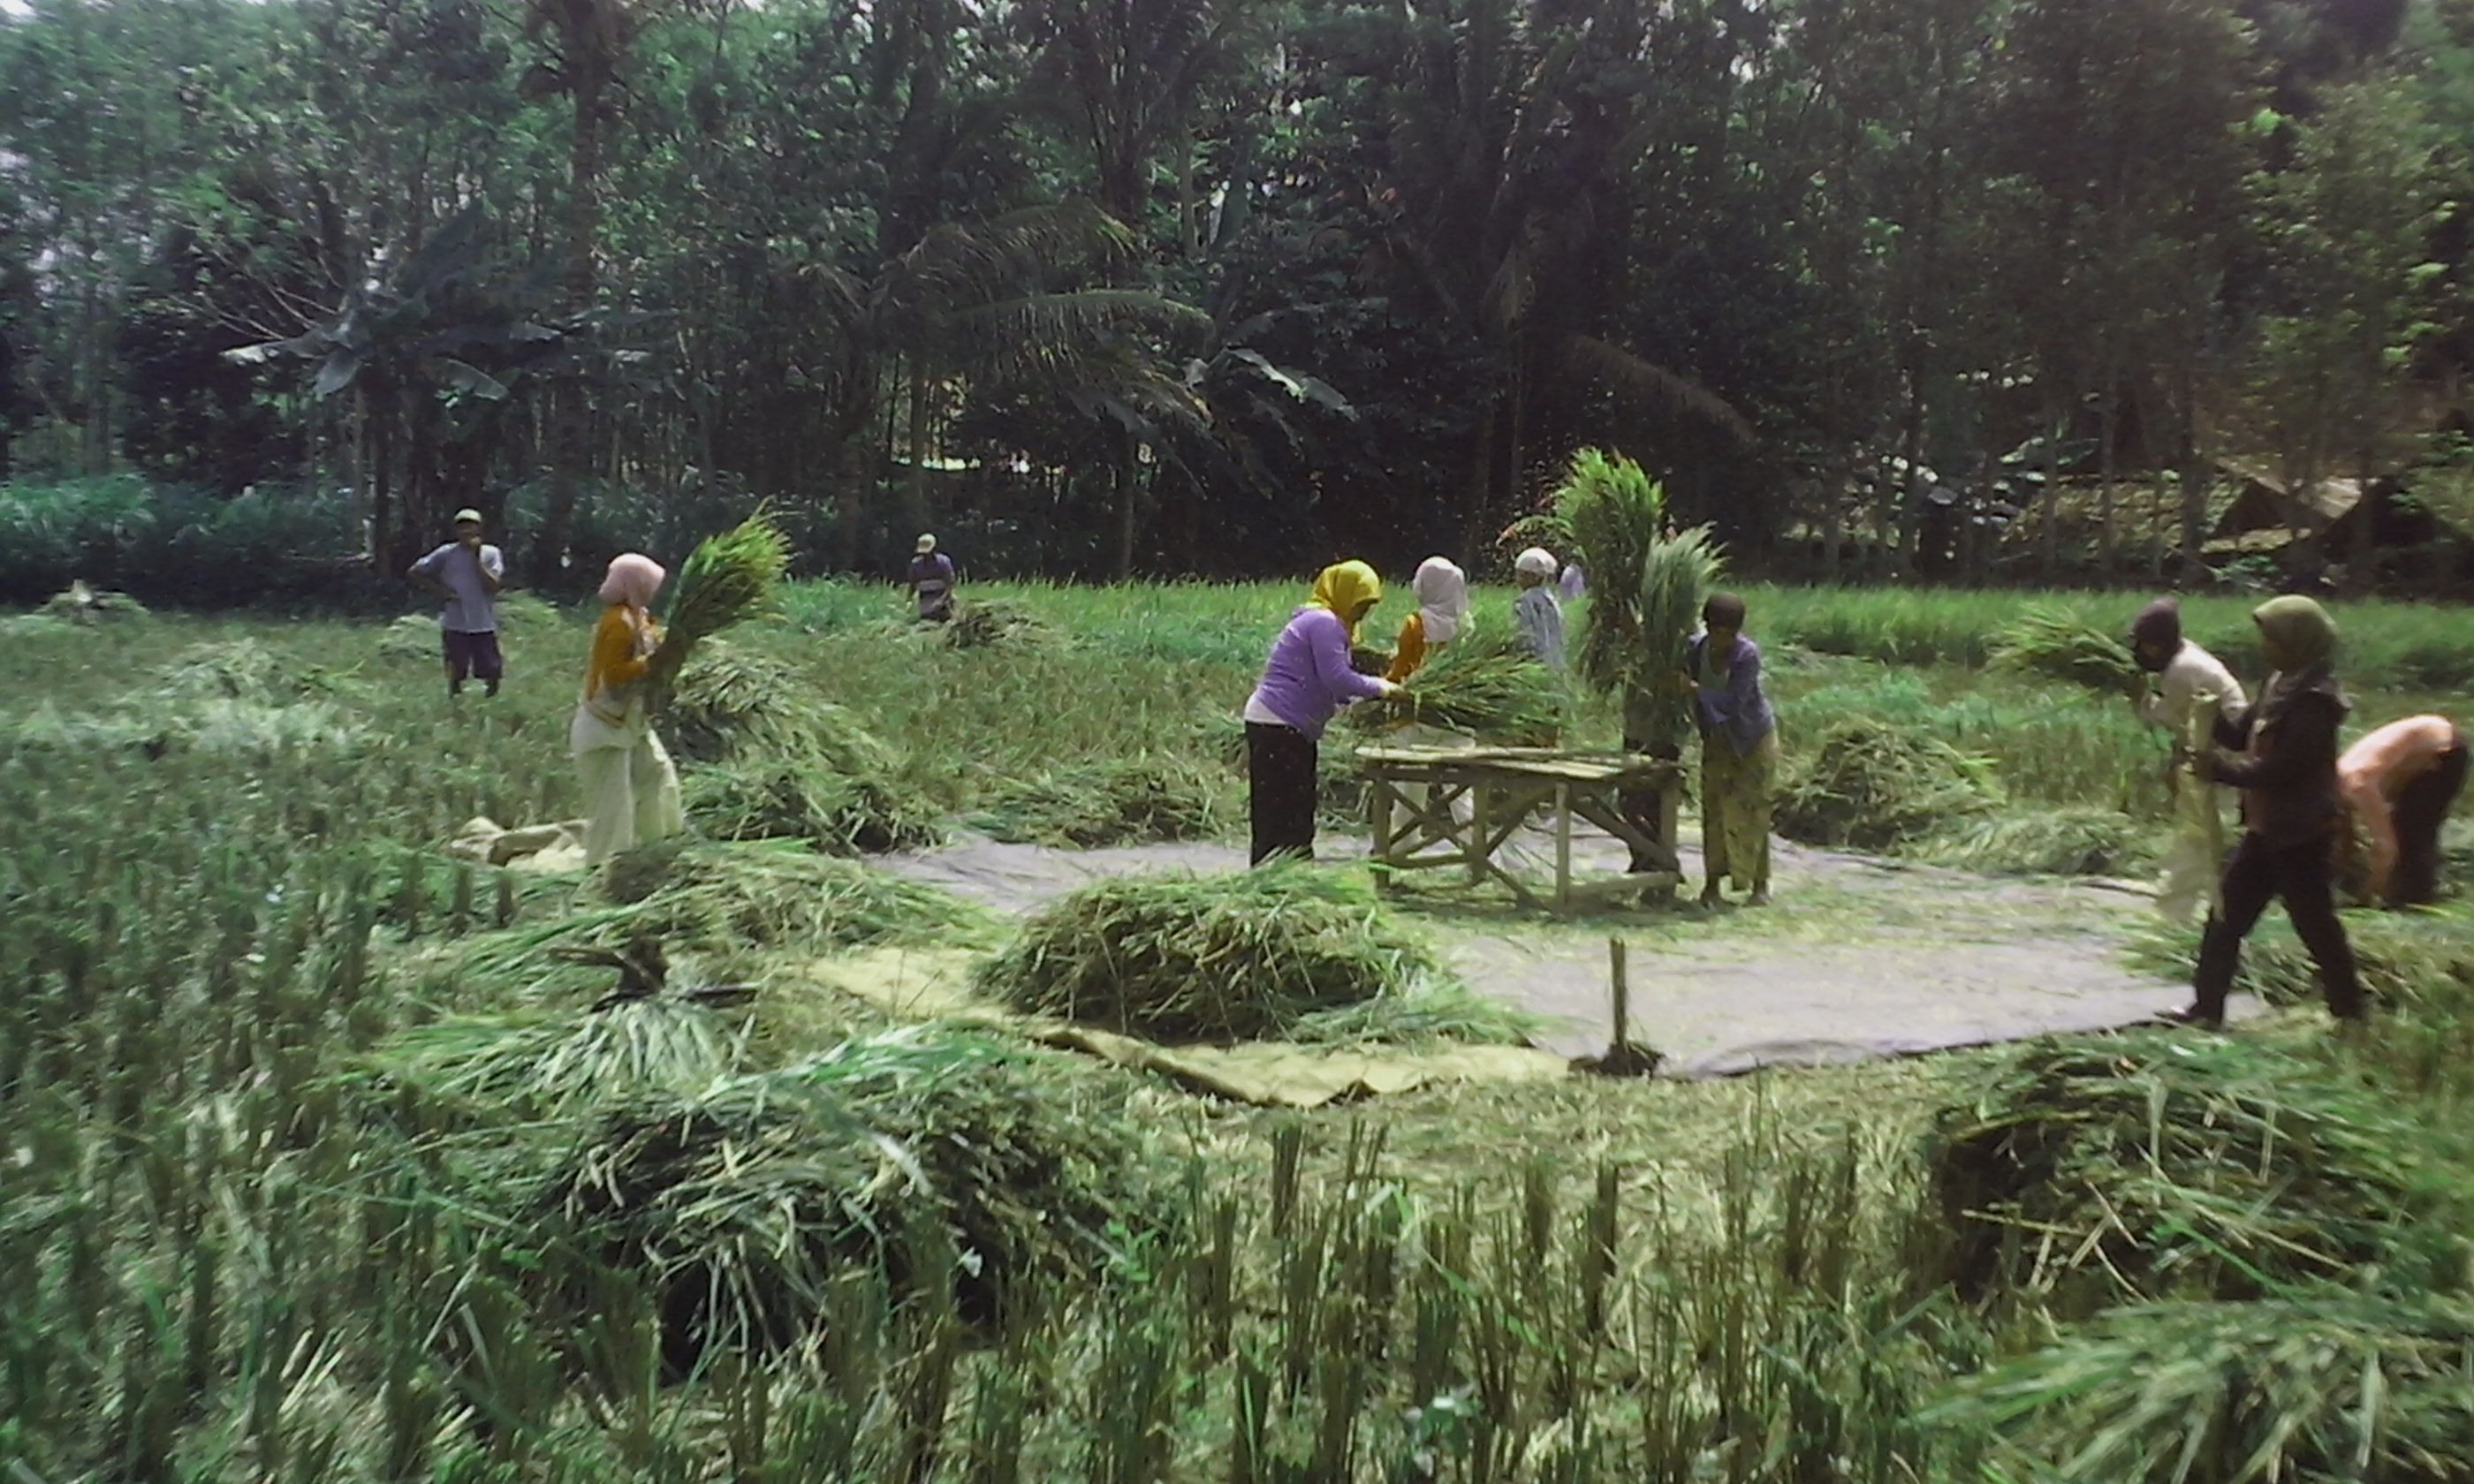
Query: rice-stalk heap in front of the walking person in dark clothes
[{"left": 1930, "top": 1034, "right": 2464, "bottom": 1306}]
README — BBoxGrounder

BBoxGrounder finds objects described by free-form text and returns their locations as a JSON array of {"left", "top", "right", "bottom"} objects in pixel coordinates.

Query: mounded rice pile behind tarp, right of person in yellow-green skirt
[{"left": 1776, "top": 717, "right": 2001, "bottom": 851}]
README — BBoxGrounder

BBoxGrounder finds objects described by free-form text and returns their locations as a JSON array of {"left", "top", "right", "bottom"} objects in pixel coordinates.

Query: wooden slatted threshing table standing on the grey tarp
[{"left": 1358, "top": 747, "right": 1682, "bottom": 912}]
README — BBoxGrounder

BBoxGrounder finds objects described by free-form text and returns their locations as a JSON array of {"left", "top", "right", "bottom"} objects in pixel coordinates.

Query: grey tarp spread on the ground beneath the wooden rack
[{"left": 888, "top": 831, "right": 2257, "bottom": 1076}]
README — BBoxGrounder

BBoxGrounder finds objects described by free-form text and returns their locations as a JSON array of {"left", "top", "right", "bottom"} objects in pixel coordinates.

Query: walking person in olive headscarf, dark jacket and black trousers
[{"left": 2172, "top": 596, "right": 2363, "bottom": 1026}]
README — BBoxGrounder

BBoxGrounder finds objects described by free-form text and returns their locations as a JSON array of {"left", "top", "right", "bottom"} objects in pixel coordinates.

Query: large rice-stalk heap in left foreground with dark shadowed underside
[{"left": 550, "top": 1026, "right": 1160, "bottom": 1355}]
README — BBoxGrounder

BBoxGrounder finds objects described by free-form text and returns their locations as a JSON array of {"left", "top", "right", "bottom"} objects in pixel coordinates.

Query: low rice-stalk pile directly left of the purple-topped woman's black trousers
[{"left": 970, "top": 754, "right": 1237, "bottom": 848}]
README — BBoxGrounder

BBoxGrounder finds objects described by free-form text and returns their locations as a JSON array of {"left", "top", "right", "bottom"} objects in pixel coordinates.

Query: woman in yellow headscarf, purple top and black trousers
[{"left": 1244, "top": 562, "right": 1398, "bottom": 866}]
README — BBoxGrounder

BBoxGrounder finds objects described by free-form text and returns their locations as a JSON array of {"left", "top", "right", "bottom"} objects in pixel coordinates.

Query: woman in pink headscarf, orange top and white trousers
[{"left": 566, "top": 551, "right": 686, "bottom": 866}]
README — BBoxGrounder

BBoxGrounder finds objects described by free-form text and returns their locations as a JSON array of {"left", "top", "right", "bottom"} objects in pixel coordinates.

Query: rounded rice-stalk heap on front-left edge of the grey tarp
[{"left": 975, "top": 863, "right": 1438, "bottom": 1044}]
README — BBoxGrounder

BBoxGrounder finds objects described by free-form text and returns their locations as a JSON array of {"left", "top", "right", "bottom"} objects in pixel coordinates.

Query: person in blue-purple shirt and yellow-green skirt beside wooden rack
[{"left": 1685, "top": 594, "right": 1779, "bottom": 908}]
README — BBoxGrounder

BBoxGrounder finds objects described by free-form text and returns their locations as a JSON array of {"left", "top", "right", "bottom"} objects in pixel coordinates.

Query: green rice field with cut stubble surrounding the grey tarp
[{"left": 0, "top": 584, "right": 2474, "bottom": 1484}]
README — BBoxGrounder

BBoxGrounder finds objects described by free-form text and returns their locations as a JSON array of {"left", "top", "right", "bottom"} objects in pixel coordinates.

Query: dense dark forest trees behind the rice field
[{"left": 0, "top": 0, "right": 2474, "bottom": 581}]
